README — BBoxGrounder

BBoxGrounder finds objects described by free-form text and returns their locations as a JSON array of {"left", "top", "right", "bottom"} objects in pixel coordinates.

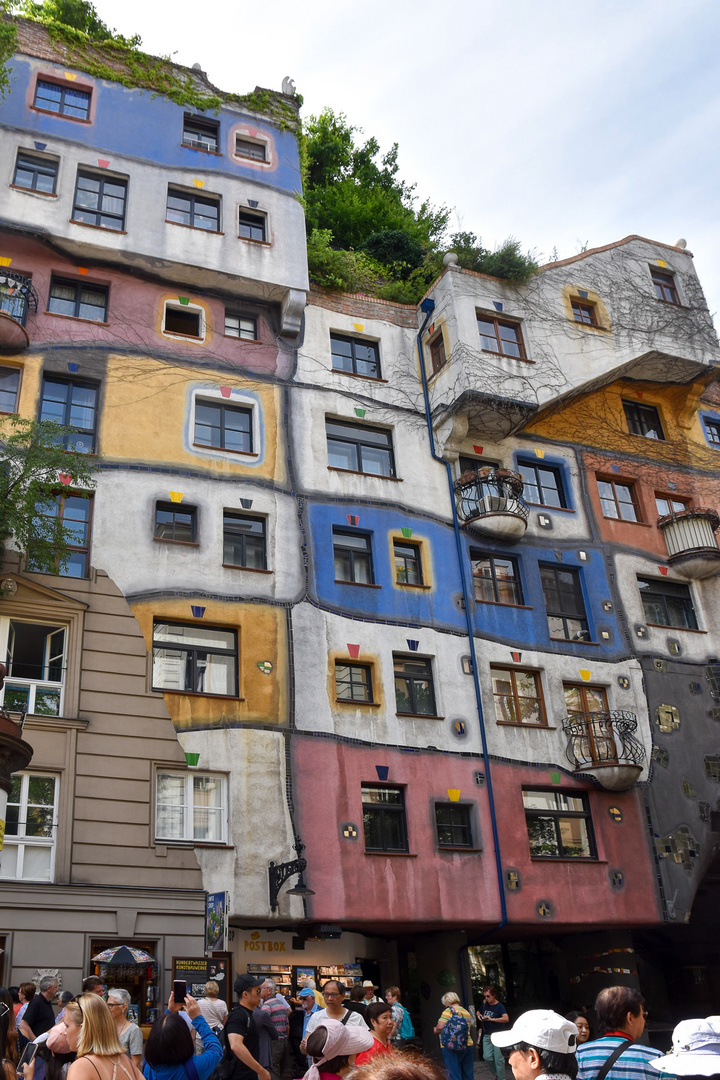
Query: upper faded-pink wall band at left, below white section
[{"left": 0, "top": 235, "right": 290, "bottom": 378}]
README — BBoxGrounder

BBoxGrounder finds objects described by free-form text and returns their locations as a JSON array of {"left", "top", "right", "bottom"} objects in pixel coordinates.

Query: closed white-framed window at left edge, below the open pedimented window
[{"left": 0, "top": 772, "right": 58, "bottom": 881}]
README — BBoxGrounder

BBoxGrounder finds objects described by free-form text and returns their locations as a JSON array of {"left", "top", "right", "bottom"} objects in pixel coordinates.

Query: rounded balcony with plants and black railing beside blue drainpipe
[{"left": 454, "top": 469, "right": 530, "bottom": 542}]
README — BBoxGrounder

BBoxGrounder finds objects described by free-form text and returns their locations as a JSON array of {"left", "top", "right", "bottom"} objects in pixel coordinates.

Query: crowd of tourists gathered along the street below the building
[{"left": 0, "top": 973, "right": 720, "bottom": 1080}]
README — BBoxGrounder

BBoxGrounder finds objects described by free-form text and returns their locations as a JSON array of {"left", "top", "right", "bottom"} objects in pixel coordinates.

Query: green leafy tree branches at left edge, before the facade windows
[{"left": 0, "top": 416, "right": 97, "bottom": 573}]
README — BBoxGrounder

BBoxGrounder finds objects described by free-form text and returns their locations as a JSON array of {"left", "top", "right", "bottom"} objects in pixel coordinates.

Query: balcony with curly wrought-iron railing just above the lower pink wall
[{"left": 562, "top": 712, "right": 646, "bottom": 792}]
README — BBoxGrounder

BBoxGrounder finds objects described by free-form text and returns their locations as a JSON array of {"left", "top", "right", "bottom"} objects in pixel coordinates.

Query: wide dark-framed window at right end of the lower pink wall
[{"left": 522, "top": 791, "right": 595, "bottom": 859}]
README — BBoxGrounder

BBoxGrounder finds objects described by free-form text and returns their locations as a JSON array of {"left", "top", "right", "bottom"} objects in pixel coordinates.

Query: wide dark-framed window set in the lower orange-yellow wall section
[{"left": 152, "top": 622, "right": 237, "bottom": 698}]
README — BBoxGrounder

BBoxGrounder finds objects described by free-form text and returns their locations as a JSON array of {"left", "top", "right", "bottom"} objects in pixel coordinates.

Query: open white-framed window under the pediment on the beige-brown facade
[{"left": 0, "top": 621, "right": 66, "bottom": 716}]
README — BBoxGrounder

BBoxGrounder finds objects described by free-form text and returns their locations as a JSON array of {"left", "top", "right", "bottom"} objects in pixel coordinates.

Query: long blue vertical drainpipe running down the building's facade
[{"left": 418, "top": 297, "right": 507, "bottom": 1001}]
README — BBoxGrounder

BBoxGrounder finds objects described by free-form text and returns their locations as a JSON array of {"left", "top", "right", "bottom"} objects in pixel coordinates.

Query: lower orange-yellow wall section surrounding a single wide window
[{"left": 131, "top": 597, "right": 287, "bottom": 731}]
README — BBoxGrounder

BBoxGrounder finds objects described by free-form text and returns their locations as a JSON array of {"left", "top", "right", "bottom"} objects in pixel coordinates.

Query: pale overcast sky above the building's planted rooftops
[{"left": 95, "top": 0, "right": 720, "bottom": 313}]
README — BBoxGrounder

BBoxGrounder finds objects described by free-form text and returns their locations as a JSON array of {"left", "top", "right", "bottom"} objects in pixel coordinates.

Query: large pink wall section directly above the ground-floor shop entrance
[{"left": 293, "top": 734, "right": 660, "bottom": 933}]
